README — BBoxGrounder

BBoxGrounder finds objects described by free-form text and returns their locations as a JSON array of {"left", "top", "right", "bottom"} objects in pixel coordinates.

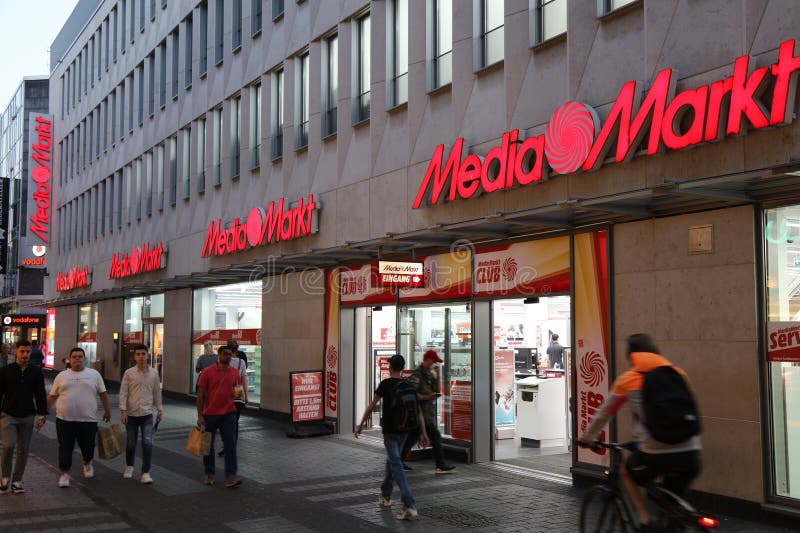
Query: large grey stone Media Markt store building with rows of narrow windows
[{"left": 46, "top": 0, "right": 800, "bottom": 512}]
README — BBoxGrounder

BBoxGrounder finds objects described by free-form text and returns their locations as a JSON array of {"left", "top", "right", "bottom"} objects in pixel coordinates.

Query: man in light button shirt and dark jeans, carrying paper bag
[{"left": 119, "top": 344, "right": 162, "bottom": 485}]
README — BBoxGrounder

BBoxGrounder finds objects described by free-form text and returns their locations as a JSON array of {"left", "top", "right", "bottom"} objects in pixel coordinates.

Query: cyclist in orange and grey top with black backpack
[{"left": 578, "top": 333, "right": 701, "bottom": 531}]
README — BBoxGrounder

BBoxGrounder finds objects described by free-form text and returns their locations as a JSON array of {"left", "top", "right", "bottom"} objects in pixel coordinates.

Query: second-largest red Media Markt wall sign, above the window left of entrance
[{"left": 201, "top": 194, "right": 319, "bottom": 257}]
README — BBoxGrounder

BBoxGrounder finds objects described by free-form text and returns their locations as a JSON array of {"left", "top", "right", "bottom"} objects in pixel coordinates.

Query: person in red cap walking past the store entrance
[{"left": 402, "top": 350, "right": 455, "bottom": 474}]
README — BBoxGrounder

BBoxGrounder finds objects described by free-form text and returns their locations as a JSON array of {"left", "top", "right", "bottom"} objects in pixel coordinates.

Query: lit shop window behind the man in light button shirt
[{"left": 122, "top": 294, "right": 164, "bottom": 383}]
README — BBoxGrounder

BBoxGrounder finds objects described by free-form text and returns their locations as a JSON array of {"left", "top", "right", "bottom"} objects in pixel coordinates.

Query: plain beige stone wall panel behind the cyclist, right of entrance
[{"left": 613, "top": 207, "right": 763, "bottom": 501}]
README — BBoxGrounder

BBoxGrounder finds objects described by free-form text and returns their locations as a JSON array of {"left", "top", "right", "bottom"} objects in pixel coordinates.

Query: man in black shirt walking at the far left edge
[{"left": 0, "top": 340, "right": 47, "bottom": 494}]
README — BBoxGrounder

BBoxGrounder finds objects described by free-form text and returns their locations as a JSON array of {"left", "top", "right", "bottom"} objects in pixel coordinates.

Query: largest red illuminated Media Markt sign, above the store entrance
[{"left": 413, "top": 39, "right": 800, "bottom": 209}]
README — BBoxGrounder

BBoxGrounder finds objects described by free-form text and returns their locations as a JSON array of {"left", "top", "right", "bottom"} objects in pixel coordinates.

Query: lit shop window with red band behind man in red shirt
[{"left": 189, "top": 282, "right": 262, "bottom": 405}]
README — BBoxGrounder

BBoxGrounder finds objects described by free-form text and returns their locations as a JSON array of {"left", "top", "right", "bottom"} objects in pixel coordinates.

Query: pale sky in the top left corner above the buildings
[{"left": 0, "top": 0, "right": 78, "bottom": 109}]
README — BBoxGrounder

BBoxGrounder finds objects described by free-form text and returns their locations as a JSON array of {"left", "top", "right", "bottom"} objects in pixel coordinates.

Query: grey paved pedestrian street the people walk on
[{"left": 0, "top": 386, "right": 786, "bottom": 533}]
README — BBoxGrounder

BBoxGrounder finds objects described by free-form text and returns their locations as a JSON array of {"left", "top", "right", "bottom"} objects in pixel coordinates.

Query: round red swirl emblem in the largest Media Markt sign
[{"left": 544, "top": 102, "right": 597, "bottom": 174}]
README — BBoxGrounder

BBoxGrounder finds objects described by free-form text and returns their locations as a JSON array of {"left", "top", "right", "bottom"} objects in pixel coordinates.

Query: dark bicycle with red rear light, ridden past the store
[{"left": 580, "top": 441, "right": 719, "bottom": 533}]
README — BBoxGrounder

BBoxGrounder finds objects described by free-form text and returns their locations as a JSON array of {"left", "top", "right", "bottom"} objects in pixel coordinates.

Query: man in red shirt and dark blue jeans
[{"left": 197, "top": 346, "right": 244, "bottom": 488}]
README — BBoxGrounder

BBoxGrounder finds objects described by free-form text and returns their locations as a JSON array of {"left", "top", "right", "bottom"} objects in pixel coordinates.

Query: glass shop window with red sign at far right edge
[{"left": 764, "top": 206, "right": 800, "bottom": 499}]
